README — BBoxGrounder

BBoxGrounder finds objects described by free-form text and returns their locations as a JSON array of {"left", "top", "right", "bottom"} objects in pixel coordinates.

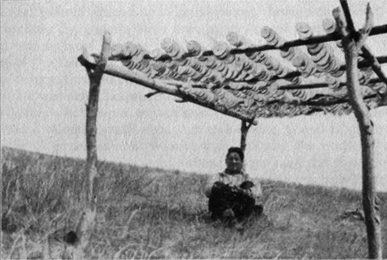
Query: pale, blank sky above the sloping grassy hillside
[{"left": 1, "top": 0, "right": 387, "bottom": 191}]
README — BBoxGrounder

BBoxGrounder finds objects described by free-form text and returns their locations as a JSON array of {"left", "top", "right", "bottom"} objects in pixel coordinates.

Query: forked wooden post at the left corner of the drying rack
[{"left": 76, "top": 32, "right": 111, "bottom": 258}]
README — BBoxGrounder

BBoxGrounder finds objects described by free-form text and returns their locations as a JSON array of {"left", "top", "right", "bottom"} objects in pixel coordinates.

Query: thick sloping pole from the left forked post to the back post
[{"left": 78, "top": 54, "right": 257, "bottom": 125}]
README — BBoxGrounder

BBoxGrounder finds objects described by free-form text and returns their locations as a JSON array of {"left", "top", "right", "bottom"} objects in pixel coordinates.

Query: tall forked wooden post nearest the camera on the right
[{"left": 333, "top": 0, "right": 382, "bottom": 259}]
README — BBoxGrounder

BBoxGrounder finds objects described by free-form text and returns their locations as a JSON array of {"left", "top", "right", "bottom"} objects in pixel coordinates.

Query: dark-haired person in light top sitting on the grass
[{"left": 204, "top": 147, "right": 263, "bottom": 222}]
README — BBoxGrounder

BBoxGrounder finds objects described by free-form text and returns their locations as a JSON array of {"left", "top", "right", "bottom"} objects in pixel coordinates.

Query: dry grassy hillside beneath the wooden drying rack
[{"left": 1, "top": 148, "right": 387, "bottom": 259}]
